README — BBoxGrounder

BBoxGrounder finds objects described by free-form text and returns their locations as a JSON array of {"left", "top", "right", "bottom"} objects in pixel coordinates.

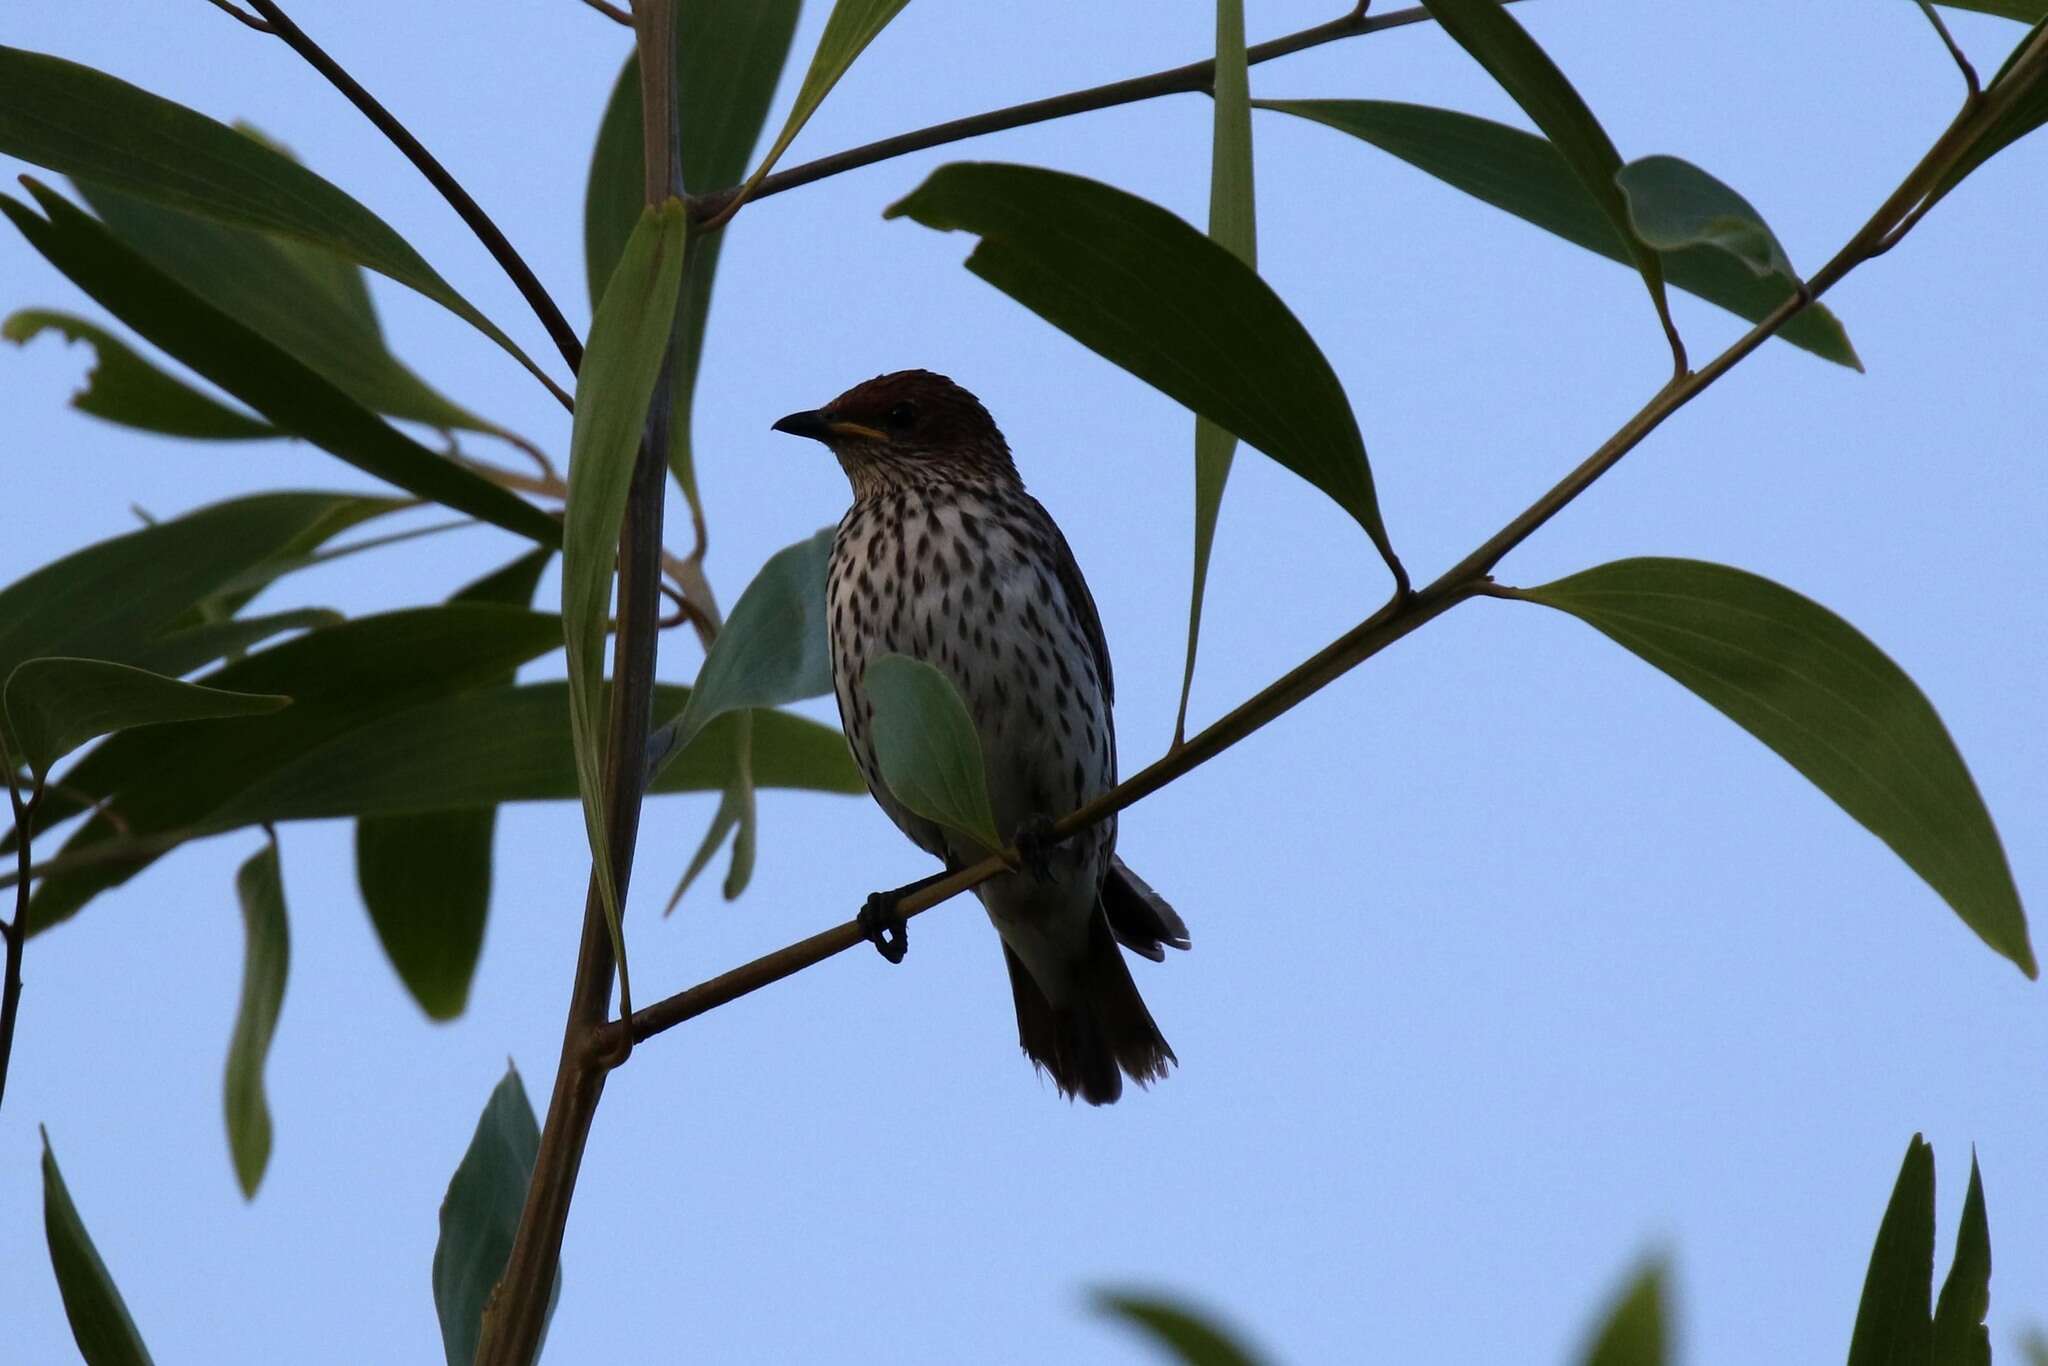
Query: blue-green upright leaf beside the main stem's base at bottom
[{"left": 434, "top": 1065, "right": 561, "bottom": 1366}]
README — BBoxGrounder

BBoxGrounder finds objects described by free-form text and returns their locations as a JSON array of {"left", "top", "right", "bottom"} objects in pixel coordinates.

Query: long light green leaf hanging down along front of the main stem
[{"left": 561, "top": 199, "right": 684, "bottom": 958}]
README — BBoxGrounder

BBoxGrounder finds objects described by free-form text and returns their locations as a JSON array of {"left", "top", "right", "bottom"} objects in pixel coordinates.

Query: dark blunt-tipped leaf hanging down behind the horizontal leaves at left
[{"left": 356, "top": 547, "right": 553, "bottom": 1020}]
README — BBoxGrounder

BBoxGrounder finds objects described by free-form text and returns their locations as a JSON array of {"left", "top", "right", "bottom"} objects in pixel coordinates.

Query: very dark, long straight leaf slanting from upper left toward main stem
[{"left": 0, "top": 182, "right": 561, "bottom": 545}]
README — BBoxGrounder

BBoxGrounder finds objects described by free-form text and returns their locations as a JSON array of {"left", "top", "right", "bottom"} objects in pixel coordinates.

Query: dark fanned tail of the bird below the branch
[{"left": 1004, "top": 909, "right": 1180, "bottom": 1106}]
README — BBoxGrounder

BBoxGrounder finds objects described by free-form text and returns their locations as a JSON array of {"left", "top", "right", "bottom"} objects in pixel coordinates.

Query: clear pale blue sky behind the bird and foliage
[{"left": 0, "top": 0, "right": 2048, "bottom": 1364}]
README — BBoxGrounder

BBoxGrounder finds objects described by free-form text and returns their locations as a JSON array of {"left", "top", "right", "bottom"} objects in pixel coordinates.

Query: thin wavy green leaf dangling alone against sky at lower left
[{"left": 223, "top": 840, "right": 291, "bottom": 1200}]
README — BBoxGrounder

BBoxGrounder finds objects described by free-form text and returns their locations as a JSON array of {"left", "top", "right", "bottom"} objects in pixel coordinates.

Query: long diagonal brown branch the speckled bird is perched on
[{"left": 608, "top": 33, "right": 2048, "bottom": 1040}]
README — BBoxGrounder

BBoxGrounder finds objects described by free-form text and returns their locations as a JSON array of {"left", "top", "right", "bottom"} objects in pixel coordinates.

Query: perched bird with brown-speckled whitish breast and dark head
[{"left": 774, "top": 371, "right": 1188, "bottom": 1106}]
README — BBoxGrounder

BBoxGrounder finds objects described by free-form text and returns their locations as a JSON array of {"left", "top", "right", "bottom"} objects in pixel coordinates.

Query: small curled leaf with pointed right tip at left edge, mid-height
[{"left": 6, "top": 657, "right": 291, "bottom": 780}]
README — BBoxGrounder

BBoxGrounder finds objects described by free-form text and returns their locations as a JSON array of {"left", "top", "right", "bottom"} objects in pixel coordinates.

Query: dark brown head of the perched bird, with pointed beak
[{"left": 774, "top": 371, "right": 1018, "bottom": 500}]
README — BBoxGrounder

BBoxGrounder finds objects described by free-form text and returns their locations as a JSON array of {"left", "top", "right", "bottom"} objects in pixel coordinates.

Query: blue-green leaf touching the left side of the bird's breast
[{"left": 647, "top": 526, "right": 834, "bottom": 764}]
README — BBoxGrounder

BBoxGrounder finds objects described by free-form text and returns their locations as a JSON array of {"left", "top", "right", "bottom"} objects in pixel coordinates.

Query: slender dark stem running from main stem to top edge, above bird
[{"left": 690, "top": 4, "right": 1466, "bottom": 223}]
